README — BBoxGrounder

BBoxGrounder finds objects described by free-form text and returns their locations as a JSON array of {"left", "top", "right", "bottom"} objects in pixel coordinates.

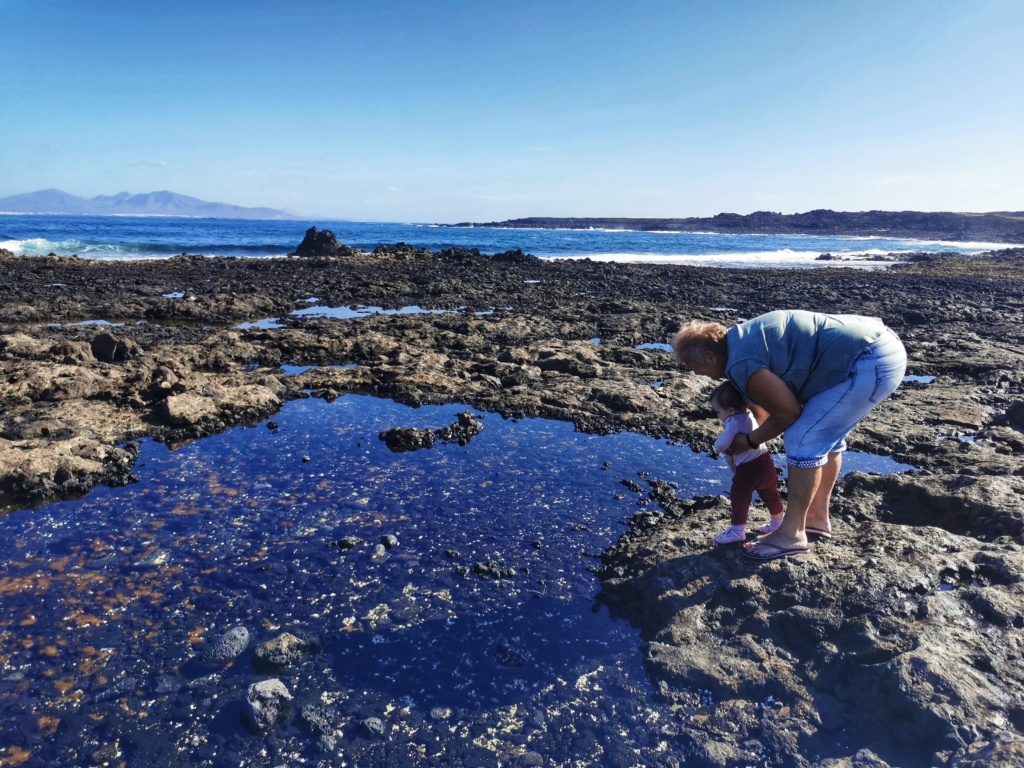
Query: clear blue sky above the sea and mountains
[{"left": 0, "top": 0, "right": 1024, "bottom": 222}]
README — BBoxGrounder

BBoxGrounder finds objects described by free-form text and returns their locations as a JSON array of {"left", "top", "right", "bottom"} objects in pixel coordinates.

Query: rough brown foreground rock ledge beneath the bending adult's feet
[{"left": 601, "top": 487, "right": 1024, "bottom": 767}]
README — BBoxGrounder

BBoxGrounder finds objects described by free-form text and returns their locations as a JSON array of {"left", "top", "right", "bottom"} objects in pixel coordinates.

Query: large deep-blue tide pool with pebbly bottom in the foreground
[{"left": 0, "top": 395, "right": 913, "bottom": 767}]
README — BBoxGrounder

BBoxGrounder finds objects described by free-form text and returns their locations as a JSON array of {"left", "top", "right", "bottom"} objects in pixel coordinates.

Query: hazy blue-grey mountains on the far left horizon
[{"left": 0, "top": 189, "right": 302, "bottom": 219}]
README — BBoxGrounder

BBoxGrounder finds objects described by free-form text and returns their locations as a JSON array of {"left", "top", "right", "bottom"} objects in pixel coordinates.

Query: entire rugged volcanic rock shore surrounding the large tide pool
[{"left": 0, "top": 244, "right": 1024, "bottom": 766}]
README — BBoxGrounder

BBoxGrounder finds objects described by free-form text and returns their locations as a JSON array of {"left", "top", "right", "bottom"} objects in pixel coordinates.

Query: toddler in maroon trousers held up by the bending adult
[{"left": 711, "top": 381, "right": 783, "bottom": 544}]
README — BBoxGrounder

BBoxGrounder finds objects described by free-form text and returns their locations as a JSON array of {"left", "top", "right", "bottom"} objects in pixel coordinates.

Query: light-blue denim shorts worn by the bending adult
[{"left": 782, "top": 329, "right": 906, "bottom": 469}]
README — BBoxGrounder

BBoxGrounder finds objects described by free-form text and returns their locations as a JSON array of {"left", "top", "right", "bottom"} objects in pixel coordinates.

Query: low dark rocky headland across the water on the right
[{"left": 449, "top": 209, "right": 1024, "bottom": 243}]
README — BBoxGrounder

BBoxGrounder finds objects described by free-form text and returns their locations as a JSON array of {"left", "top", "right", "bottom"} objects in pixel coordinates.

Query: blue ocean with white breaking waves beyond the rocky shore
[{"left": 0, "top": 214, "right": 1005, "bottom": 268}]
